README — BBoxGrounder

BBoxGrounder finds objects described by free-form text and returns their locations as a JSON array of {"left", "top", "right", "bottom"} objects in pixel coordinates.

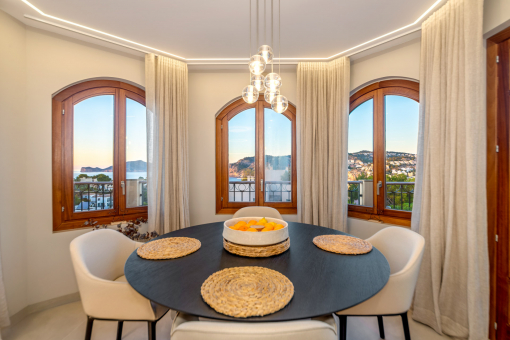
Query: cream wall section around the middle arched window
[{"left": 188, "top": 70, "right": 297, "bottom": 225}]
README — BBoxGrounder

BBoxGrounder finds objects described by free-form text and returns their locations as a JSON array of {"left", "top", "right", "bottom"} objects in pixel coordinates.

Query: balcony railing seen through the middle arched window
[{"left": 228, "top": 181, "right": 292, "bottom": 202}]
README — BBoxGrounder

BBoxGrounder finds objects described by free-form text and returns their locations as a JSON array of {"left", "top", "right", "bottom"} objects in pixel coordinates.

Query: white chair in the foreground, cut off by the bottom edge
[{"left": 170, "top": 313, "right": 338, "bottom": 340}]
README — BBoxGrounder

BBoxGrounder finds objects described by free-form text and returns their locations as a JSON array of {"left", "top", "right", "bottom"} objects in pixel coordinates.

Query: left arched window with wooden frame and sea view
[{"left": 52, "top": 80, "right": 147, "bottom": 231}]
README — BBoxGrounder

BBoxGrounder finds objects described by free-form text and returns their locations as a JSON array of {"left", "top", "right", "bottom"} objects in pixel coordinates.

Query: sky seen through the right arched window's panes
[{"left": 348, "top": 95, "right": 419, "bottom": 154}]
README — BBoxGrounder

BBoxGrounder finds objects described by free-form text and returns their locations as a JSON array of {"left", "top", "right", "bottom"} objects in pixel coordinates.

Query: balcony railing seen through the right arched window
[{"left": 347, "top": 181, "right": 414, "bottom": 211}]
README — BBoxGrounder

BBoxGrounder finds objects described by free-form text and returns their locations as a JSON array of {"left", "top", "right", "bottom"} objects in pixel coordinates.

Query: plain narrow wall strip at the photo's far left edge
[{"left": 0, "top": 11, "right": 28, "bottom": 315}]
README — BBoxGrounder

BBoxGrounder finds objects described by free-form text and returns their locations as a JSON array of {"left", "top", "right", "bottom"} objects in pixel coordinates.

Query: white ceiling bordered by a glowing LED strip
[{"left": 0, "top": 0, "right": 445, "bottom": 62}]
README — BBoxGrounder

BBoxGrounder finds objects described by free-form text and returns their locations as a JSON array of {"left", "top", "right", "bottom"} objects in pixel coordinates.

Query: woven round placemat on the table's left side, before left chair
[{"left": 136, "top": 237, "right": 202, "bottom": 260}]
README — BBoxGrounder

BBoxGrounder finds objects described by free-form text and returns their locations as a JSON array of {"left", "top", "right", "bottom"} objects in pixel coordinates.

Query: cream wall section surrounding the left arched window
[{"left": 23, "top": 28, "right": 145, "bottom": 304}]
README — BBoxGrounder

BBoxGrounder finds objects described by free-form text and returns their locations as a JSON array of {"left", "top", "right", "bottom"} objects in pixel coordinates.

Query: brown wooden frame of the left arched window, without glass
[{"left": 52, "top": 80, "right": 147, "bottom": 232}]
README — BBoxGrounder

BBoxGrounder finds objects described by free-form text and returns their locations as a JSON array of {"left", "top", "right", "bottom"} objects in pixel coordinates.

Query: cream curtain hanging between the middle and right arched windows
[{"left": 296, "top": 57, "right": 350, "bottom": 231}]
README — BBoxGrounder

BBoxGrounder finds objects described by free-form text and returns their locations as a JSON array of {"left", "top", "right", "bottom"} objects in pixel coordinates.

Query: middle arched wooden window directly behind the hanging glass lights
[{"left": 216, "top": 96, "right": 297, "bottom": 214}]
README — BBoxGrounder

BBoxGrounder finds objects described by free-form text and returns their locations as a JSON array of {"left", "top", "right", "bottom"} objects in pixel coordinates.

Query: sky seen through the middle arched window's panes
[{"left": 228, "top": 108, "right": 292, "bottom": 163}]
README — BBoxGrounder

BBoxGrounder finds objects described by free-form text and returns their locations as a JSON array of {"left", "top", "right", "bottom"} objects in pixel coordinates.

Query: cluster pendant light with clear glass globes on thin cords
[{"left": 243, "top": 0, "right": 289, "bottom": 113}]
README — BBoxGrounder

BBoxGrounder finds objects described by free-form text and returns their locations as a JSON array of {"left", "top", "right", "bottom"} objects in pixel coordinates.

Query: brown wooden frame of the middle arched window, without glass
[{"left": 216, "top": 95, "right": 297, "bottom": 214}]
